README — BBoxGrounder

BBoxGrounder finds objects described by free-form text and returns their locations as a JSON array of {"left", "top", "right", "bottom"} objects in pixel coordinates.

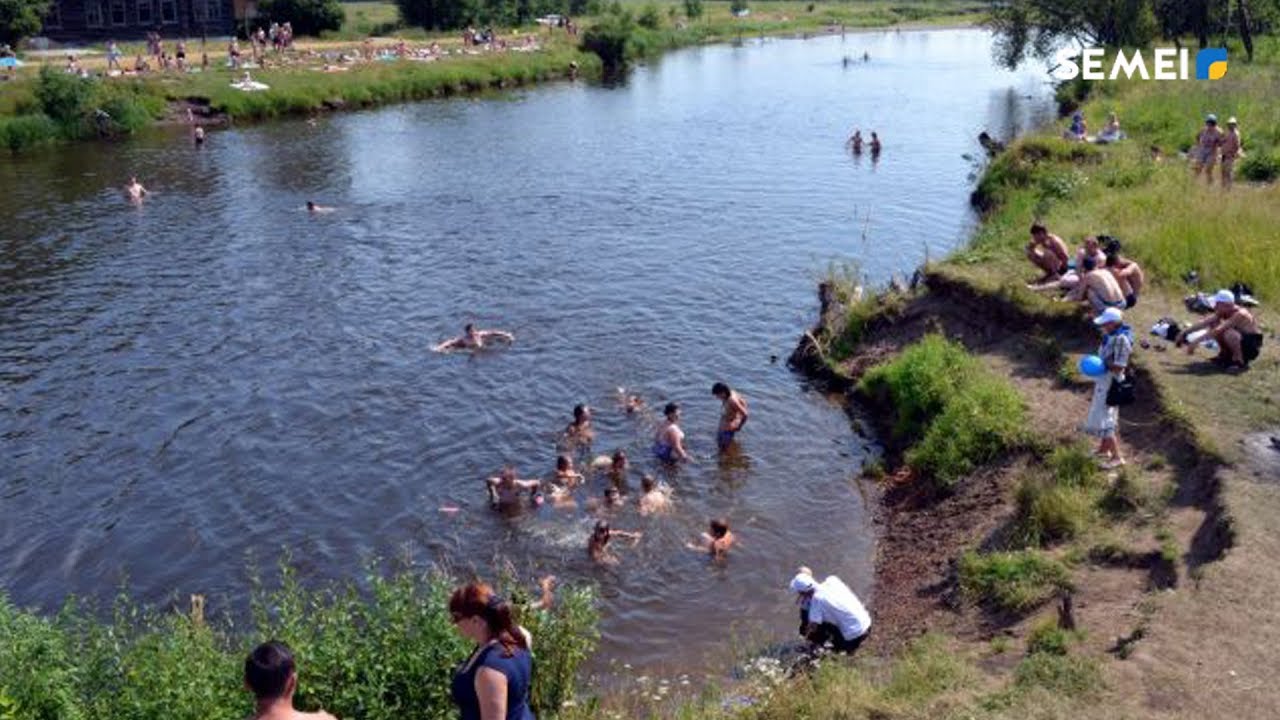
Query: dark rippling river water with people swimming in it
[{"left": 0, "top": 31, "right": 1048, "bottom": 671}]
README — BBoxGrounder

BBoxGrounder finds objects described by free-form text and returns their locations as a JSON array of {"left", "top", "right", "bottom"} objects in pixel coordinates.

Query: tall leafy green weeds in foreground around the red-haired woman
[{"left": 0, "top": 561, "right": 596, "bottom": 720}]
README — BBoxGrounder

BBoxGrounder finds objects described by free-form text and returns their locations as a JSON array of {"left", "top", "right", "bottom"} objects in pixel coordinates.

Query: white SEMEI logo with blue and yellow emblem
[{"left": 1052, "top": 47, "right": 1226, "bottom": 79}]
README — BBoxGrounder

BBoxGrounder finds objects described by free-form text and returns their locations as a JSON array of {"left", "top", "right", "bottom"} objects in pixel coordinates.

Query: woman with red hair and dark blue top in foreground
[{"left": 449, "top": 583, "right": 535, "bottom": 720}]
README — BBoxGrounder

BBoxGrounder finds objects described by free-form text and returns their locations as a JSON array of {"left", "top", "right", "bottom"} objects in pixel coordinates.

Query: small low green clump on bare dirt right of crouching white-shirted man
[{"left": 960, "top": 550, "right": 1070, "bottom": 612}]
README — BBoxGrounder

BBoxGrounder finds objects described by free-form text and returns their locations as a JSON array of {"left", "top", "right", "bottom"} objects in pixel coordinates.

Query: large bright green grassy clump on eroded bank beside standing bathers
[{"left": 859, "top": 334, "right": 1025, "bottom": 491}]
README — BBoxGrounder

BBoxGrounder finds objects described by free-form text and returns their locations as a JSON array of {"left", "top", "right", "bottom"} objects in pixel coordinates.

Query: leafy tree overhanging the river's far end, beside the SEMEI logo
[{"left": 989, "top": 0, "right": 1157, "bottom": 68}]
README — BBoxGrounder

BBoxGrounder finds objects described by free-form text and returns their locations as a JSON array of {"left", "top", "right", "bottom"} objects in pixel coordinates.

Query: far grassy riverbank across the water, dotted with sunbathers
[{"left": 0, "top": 0, "right": 982, "bottom": 151}]
